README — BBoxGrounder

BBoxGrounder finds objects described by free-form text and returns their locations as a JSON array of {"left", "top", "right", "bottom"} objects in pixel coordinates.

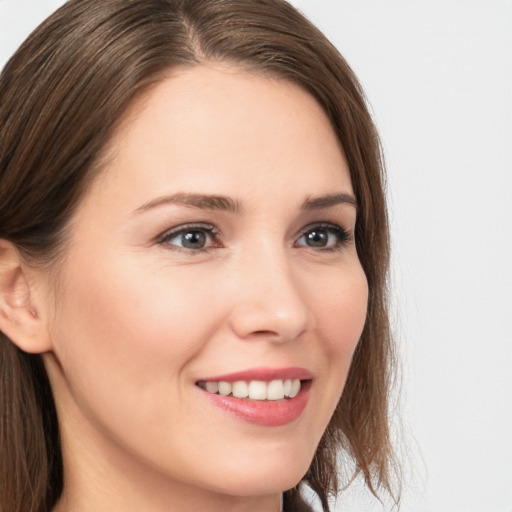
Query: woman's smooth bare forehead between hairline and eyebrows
[{"left": 88, "top": 65, "right": 351, "bottom": 212}]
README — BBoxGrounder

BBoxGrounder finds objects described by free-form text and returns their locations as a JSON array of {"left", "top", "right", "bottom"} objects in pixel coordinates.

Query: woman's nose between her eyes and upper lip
[{"left": 230, "top": 245, "right": 309, "bottom": 343}]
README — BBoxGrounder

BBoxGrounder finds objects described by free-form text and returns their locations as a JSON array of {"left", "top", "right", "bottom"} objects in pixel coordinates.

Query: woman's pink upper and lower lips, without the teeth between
[{"left": 197, "top": 367, "right": 313, "bottom": 427}]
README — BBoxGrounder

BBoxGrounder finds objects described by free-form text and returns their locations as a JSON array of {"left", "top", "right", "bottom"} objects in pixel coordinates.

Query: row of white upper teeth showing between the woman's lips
[{"left": 198, "top": 379, "right": 301, "bottom": 400}]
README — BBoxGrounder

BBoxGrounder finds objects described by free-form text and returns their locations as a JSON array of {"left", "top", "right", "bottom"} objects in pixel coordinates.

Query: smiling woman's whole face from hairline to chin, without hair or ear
[{"left": 45, "top": 66, "right": 367, "bottom": 504}]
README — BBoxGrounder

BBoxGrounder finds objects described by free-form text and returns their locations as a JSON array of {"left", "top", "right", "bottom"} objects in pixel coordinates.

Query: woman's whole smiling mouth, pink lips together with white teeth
[{"left": 196, "top": 367, "right": 313, "bottom": 427}]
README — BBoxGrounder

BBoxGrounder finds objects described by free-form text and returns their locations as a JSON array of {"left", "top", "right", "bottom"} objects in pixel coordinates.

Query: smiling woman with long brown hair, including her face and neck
[{"left": 0, "top": 0, "right": 393, "bottom": 512}]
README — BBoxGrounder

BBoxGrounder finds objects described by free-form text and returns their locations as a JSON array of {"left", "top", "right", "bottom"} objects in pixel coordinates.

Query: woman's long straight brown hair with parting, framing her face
[{"left": 0, "top": 0, "right": 394, "bottom": 512}]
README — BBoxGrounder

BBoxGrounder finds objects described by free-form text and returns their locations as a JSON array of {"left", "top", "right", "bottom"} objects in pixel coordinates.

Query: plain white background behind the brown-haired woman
[{"left": 0, "top": 0, "right": 512, "bottom": 512}]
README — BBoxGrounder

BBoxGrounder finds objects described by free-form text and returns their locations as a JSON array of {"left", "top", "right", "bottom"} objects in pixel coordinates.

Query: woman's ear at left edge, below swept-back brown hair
[{"left": 0, "top": 239, "right": 50, "bottom": 354}]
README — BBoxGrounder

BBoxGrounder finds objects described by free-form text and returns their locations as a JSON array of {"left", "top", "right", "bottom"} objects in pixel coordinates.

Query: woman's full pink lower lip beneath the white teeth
[{"left": 198, "top": 381, "right": 311, "bottom": 427}]
